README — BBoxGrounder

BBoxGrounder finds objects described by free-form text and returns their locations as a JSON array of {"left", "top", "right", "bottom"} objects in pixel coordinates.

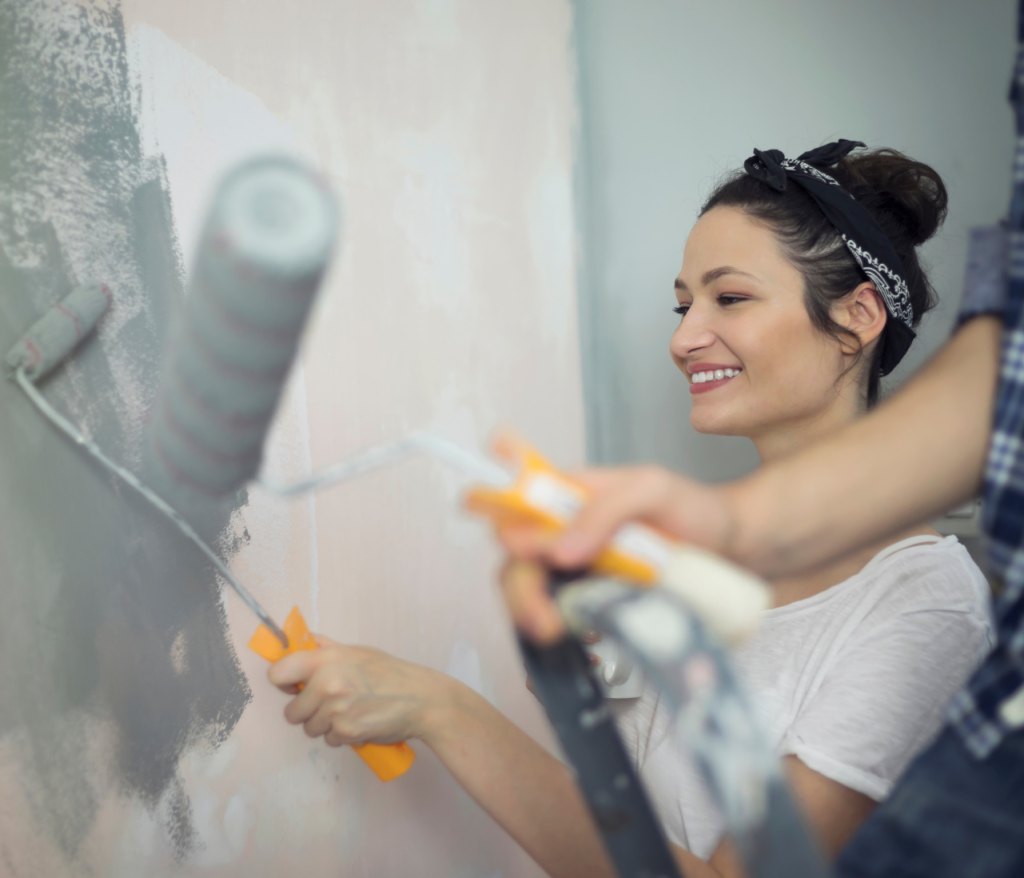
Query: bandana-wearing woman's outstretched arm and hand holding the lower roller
[{"left": 267, "top": 637, "right": 614, "bottom": 878}]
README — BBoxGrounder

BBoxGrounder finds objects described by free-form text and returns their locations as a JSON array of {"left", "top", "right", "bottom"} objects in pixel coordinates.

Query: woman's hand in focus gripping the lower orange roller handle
[{"left": 267, "top": 635, "right": 452, "bottom": 747}]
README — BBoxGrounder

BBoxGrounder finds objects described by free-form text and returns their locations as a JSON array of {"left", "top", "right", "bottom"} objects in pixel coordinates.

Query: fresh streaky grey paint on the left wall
[{"left": 0, "top": 0, "right": 250, "bottom": 861}]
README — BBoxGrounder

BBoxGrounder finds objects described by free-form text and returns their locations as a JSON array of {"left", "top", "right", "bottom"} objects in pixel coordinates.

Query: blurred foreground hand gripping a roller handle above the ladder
[{"left": 499, "top": 466, "right": 733, "bottom": 645}]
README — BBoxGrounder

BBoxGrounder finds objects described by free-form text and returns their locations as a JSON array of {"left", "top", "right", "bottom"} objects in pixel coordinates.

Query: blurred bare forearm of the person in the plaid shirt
[{"left": 724, "top": 318, "right": 1001, "bottom": 576}]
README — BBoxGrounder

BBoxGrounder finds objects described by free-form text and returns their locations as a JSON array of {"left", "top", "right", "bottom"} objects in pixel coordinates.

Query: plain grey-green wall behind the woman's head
[{"left": 575, "top": 0, "right": 1016, "bottom": 479}]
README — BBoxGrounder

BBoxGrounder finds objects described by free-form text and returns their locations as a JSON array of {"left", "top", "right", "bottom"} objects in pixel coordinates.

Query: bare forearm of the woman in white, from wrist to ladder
[{"left": 422, "top": 680, "right": 614, "bottom": 878}]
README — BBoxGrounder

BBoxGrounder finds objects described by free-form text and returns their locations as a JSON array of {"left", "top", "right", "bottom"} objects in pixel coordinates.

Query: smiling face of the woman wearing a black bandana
[{"left": 670, "top": 207, "right": 848, "bottom": 440}]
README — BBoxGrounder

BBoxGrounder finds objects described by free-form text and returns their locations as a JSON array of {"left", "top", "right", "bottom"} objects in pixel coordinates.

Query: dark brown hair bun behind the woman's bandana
[{"left": 834, "top": 149, "right": 949, "bottom": 252}]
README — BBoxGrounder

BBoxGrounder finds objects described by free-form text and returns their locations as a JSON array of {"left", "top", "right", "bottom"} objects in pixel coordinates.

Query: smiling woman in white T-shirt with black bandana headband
[{"left": 269, "top": 141, "right": 990, "bottom": 878}]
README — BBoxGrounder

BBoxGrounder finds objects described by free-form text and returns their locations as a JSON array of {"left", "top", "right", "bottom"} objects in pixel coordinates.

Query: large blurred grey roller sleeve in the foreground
[{"left": 152, "top": 157, "right": 339, "bottom": 494}]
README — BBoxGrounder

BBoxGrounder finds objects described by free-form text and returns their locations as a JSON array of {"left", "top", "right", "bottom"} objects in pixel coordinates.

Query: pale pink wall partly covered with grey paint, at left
[{"left": 0, "top": 0, "right": 584, "bottom": 878}]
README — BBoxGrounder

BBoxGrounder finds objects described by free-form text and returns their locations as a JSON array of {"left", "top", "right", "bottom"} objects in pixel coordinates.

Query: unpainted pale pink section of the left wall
[{"left": 103, "top": 0, "right": 584, "bottom": 878}]
